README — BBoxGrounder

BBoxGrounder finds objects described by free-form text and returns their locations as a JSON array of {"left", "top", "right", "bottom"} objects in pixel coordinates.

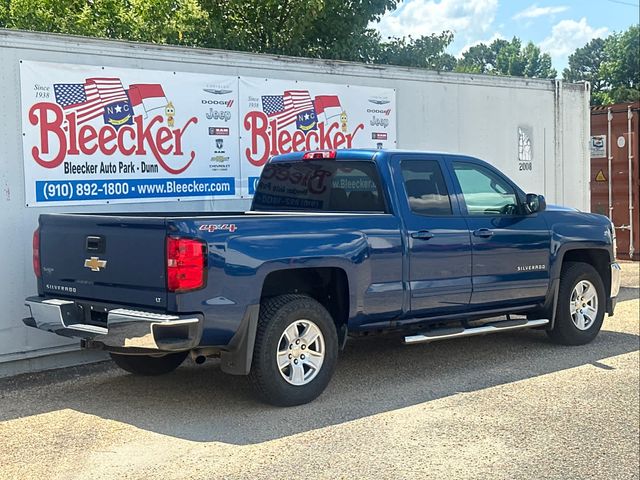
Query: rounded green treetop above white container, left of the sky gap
[{"left": 456, "top": 37, "right": 557, "bottom": 78}]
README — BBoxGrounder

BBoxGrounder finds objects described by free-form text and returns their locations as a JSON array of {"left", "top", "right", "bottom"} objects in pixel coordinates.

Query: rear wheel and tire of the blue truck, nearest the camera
[{"left": 249, "top": 295, "right": 338, "bottom": 407}]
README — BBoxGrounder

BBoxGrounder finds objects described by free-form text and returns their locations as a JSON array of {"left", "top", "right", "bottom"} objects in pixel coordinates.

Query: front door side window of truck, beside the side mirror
[{"left": 453, "top": 162, "right": 518, "bottom": 215}]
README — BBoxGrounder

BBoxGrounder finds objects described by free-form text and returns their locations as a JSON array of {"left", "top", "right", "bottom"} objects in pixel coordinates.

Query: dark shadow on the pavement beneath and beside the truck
[{"left": 0, "top": 316, "right": 639, "bottom": 445}]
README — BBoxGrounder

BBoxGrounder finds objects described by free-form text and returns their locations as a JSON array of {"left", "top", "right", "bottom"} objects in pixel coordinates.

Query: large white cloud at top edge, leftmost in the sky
[{"left": 371, "top": 0, "right": 498, "bottom": 42}]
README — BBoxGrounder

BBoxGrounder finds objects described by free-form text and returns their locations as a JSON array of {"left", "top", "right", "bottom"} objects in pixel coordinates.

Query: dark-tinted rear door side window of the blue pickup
[{"left": 400, "top": 160, "right": 452, "bottom": 215}]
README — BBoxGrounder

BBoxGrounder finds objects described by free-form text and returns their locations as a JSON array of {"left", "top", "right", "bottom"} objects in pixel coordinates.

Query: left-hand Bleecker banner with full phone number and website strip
[{"left": 20, "top": 61, "right": 240, "bottom": 206}]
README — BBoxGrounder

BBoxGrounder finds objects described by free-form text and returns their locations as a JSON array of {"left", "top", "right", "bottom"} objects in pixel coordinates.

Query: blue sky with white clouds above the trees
[{"left": 371, "top": 0, "right": 640, "bottom": 76}]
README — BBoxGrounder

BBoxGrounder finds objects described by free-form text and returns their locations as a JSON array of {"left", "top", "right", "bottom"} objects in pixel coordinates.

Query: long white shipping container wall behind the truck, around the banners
[{"left": 0, "top": 29, "right": 590, "bottom": 375}]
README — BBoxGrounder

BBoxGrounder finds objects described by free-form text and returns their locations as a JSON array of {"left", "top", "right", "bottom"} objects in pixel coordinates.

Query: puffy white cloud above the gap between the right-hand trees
[{"left": 540, "top": 17, "right": 609, "bottom": 65}]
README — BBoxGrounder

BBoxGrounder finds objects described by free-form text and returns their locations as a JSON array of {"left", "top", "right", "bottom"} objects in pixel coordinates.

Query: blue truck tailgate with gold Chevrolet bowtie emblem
[{"left": 40, "top": 214, "right": 167, "bottom": 308}]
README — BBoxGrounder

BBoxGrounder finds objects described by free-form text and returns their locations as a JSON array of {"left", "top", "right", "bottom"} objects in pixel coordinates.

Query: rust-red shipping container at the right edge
[{"left": 590, "top": 102, "right": 640, "bottom": 260}]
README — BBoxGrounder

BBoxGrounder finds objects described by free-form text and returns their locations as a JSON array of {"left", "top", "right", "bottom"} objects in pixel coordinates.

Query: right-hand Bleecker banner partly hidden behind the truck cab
[{"left": 240, "top": 77, "right": 396, "bottom": 195}]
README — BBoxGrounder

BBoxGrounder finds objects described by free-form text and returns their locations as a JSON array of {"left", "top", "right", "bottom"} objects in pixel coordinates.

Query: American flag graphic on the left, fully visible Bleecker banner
[{"left": 53, "top": 78, "right": 129, "bottom": 124}]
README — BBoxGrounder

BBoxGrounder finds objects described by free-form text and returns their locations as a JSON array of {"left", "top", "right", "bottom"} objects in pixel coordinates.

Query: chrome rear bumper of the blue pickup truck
[{"left": 23, "top": 297, "right": 203, "bottom": 352}]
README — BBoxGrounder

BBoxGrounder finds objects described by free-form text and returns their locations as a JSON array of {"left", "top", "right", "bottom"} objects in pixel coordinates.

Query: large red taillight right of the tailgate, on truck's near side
[{"left": 167, "top": 237, "right": 206, "bottom": 292}]
